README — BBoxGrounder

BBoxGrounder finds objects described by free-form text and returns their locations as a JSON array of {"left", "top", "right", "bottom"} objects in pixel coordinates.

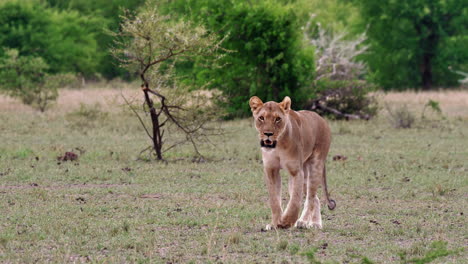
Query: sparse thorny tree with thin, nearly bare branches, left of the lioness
[{"left": 112, "top": 4, "right": 222, "bottom": 160}]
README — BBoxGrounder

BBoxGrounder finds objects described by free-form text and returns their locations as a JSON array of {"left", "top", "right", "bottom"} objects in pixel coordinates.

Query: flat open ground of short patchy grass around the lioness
[{"left": 0, "top": 89, "right": 468, "bottom": 263}]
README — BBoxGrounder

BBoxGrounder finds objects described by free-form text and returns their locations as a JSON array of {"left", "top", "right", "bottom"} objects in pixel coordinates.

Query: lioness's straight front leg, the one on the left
[{"left": 264, "top": 168, "right": 283, "bottom": 230}]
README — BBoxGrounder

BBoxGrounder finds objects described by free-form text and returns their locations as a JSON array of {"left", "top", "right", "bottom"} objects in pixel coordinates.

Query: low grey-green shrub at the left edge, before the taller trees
[{"left": 0, "top": 49, "right": 75, "bottom": 112}]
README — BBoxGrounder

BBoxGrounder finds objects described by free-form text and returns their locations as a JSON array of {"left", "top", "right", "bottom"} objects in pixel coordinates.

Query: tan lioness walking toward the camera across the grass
[{"left": 250, "top": 96, "right": 336, "bottom": 230}]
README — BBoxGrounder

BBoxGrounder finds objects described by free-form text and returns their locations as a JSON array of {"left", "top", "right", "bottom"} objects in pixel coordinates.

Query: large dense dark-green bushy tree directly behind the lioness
[{"left": 157, "top": 0, "right": 313, "bottom": 117}]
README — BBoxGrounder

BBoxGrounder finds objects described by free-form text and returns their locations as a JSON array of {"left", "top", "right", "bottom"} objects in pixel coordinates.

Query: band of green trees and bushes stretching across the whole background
[{"left": 0, "top": 0, "right": 468, "bottom": 117}]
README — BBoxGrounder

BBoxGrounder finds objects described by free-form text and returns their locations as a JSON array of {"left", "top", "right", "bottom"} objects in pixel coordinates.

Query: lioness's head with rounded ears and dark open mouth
[{"left": 250, "top": 96, "right": 291, "bottom": 148}]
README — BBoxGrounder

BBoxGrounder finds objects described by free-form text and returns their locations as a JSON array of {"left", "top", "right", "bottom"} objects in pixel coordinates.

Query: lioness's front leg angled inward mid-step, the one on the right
[{"left": 280, "top": 164, "right": 304, "bottom": 228}]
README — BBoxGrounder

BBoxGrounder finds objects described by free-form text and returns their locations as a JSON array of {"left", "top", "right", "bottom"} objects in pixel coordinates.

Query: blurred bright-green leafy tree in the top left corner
[{"left": 0, "top": 0, "right": 100, "bottom": 75}]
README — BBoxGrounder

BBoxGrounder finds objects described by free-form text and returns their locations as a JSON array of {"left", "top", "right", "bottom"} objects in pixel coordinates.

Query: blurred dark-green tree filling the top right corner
[{"left": 355, "top": 0, "right": 468, "bottom": 89}]
